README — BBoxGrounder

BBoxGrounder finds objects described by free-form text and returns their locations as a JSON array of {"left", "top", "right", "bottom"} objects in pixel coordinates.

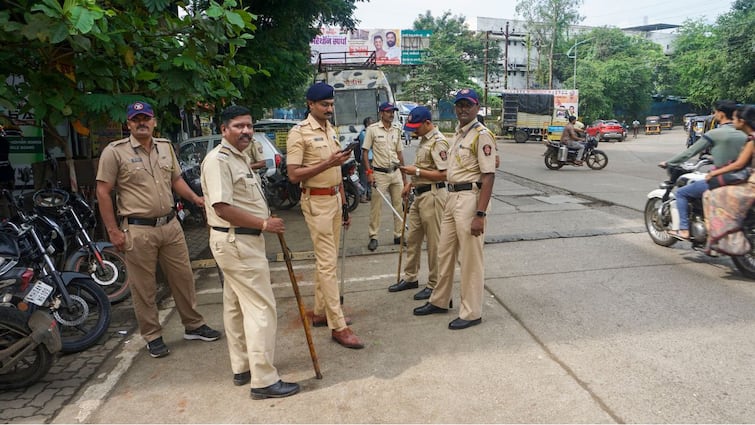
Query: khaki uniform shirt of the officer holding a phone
[{"left": 286, "top": 115, "right": 341, "bottom": 188}]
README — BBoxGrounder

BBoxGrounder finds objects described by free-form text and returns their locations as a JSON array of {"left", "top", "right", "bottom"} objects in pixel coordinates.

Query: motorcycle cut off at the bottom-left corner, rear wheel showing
[{"left": 0, "top": 233, "right": 62, "bottom": 390}]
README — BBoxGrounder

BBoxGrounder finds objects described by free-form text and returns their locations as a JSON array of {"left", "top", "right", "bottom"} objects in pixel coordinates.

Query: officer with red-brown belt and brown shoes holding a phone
[{"left": 286, "top": 82, "right": 364, "bottom": 348}]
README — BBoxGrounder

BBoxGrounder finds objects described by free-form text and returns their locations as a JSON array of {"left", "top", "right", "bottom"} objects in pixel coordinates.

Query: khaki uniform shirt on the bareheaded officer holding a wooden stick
[{"left": 202, "top": 138, "right": 270, "bottom": 227}]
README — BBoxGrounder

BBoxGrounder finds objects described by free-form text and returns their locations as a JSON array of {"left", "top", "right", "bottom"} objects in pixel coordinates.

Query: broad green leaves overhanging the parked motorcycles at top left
[{"left": 0, "top": 0, "right": 258, "bottom": 146}]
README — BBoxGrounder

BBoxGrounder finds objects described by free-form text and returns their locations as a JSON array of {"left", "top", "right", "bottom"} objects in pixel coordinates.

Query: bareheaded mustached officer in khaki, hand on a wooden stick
[{"left": 202, "top": 105, "right": 299, "bottom": 399}]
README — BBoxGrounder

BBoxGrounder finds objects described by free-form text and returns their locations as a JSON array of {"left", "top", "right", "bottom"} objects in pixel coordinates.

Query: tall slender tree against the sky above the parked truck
[{"left": 516, "top": 0, "right": 582, "bottom": 89}]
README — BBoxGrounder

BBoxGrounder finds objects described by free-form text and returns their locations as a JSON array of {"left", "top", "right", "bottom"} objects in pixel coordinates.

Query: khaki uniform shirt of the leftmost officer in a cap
[{"left": 97, "top": 137, "right": 181, "bottom": 218}]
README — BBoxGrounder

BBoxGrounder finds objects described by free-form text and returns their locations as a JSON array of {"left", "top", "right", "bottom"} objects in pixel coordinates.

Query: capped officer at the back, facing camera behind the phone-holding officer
[{"left": 362, "top": 102, "right": 404, "bottom": 251}]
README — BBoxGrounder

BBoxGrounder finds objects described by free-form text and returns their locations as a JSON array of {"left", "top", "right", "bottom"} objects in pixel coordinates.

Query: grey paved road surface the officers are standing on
[{"left": 5, "top": 127, "right": 755, "bottom": 423}]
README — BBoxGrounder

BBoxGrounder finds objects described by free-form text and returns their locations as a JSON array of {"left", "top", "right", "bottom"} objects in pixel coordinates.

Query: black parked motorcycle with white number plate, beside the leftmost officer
[{"left": 0, "top": 191, "right": 111, "bottom": 353}]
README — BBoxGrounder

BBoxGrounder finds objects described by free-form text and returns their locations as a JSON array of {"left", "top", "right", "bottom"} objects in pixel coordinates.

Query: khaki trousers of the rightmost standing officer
[{"left": 430, "top": 189, "right": 485, "bottom": 320}]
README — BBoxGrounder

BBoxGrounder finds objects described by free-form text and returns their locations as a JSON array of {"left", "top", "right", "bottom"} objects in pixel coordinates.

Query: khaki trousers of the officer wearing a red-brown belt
[{"left": 301, "top": 193, "right": 348, "bottom": 331}]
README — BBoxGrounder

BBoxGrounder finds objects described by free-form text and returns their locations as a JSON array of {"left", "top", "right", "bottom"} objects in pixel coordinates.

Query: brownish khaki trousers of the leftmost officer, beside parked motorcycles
[{"left": 122, "top": 218, "right": 205, "bottom": 342}]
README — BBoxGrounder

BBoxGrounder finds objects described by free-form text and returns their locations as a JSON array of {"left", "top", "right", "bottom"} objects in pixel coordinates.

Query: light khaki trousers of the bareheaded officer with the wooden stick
[{"left": 210, "top": 230, "right": 280, "bottom": 388}]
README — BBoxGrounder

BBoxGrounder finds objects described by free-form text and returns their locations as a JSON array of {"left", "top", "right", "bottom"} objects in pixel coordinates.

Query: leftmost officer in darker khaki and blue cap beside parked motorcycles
[{"left": 97, "top": 102, "right": 220, "bottom": 357}]
